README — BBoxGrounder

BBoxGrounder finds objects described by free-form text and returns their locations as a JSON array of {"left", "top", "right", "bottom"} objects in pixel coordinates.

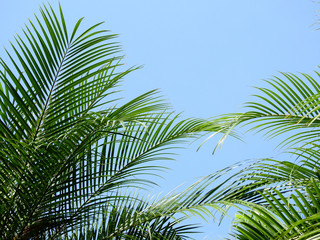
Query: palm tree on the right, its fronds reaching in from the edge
[{"left": 212, "top": 72, "right": 320, "bottom": 240}]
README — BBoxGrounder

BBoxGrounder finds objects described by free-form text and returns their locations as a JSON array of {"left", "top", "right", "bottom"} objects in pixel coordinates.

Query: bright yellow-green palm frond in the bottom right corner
[{"left": 232, "top": 178, "right": 320, "bottom": 240}]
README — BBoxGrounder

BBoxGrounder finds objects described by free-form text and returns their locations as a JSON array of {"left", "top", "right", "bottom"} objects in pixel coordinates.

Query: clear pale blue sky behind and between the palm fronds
[{"left": 0, "top": 0, "right": 320, "bottom": 239}]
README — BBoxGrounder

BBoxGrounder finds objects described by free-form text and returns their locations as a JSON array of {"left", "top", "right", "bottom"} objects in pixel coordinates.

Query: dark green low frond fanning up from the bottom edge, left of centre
[{"left": 63, "top": 191, "right": 201, "bottom": 239}]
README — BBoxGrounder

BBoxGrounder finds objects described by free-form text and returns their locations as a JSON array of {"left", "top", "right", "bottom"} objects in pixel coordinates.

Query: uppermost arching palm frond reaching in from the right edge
[{"left": 216, "top": 72, "right": 320, "bottom": 150}]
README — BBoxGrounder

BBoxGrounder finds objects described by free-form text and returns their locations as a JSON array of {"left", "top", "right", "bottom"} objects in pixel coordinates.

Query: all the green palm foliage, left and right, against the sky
[{"left": 0, "top": 2, "right": 320, "bottom": 240}]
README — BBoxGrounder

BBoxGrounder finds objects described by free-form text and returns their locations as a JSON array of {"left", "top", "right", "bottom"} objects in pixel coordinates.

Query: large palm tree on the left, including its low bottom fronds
[{"left": 0, "top": 2, "right": 252, "bottom": 239}]
